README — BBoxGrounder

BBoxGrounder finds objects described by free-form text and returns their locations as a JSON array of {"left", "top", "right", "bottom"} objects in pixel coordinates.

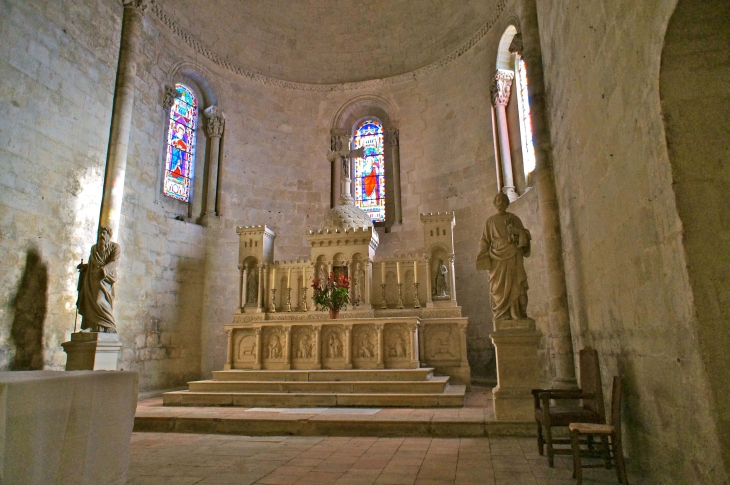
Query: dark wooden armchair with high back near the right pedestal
[{"left": 532, "top": 347, "right": 606, "bottom": 467}]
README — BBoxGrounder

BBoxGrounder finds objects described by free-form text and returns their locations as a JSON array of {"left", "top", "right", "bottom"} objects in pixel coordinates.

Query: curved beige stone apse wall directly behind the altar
[{"left": 140, "top": 0, "right": 551, "bottom": 381}]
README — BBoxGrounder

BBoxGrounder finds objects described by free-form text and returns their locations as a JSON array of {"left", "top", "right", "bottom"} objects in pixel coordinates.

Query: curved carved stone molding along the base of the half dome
[{"left": 148, "top": 0, "right": 508, "bottom": 92}]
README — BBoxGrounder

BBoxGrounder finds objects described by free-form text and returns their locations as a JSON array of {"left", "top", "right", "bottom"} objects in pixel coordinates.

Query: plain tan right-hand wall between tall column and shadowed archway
[{"left": 537, "top": 0, "right": 727, "bottom": 484}]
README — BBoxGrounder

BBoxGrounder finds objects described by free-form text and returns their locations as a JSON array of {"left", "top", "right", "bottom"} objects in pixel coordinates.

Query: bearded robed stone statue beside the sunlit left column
[{"left": 76, "top": 226, "right": 122, "bottom": 333}]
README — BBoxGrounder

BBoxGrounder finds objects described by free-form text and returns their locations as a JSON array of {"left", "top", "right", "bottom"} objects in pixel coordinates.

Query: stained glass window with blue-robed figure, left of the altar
[{"left": 163, "top": 84, "right": 198, "bottom": 202}]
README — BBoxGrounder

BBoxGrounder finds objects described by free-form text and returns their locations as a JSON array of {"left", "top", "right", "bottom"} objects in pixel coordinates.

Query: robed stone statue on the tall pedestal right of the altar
[{"left": 476, "top": 193, "right": 531, "bottom": 321}]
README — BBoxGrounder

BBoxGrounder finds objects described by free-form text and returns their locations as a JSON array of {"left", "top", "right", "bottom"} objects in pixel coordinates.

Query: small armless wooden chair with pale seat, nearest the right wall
[{"left": 568, "top": 377, "right": 629, "bottom": 485}]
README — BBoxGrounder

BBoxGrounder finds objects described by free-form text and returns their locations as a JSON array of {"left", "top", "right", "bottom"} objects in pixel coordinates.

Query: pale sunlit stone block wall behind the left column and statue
[{"left": 0, "top": 0, "right": 205, "bottom": 390}]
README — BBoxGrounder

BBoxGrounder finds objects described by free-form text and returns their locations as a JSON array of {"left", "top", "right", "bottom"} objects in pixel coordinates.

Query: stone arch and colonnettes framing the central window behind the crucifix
[{"left": 330, "top": 95, "right": 403, "bottom": 232}]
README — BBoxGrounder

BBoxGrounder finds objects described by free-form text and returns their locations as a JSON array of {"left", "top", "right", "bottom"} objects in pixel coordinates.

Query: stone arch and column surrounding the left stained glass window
[{"left": 157, "top": 62, "right": 225, "bottom": 224}]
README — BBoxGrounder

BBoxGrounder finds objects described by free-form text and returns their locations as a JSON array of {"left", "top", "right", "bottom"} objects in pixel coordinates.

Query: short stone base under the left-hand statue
[{"left": 61, "top": 332, "right": 122, "bottom": 370}]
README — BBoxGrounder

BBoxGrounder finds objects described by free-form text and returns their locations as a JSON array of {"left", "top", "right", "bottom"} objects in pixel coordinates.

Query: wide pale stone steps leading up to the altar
[{"left": 163, "top": 368, "right": 466, "bottom": 408}]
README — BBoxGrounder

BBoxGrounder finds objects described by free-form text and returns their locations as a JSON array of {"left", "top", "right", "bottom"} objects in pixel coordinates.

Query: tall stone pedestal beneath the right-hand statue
[{"left": 490, "top": 318, "right": 540, "bottom": 421}]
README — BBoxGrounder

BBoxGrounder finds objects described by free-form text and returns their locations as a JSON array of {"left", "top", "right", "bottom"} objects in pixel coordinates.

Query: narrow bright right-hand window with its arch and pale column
[{"left": 490, "top": 18, "right": 535, "bottom": 200}]
